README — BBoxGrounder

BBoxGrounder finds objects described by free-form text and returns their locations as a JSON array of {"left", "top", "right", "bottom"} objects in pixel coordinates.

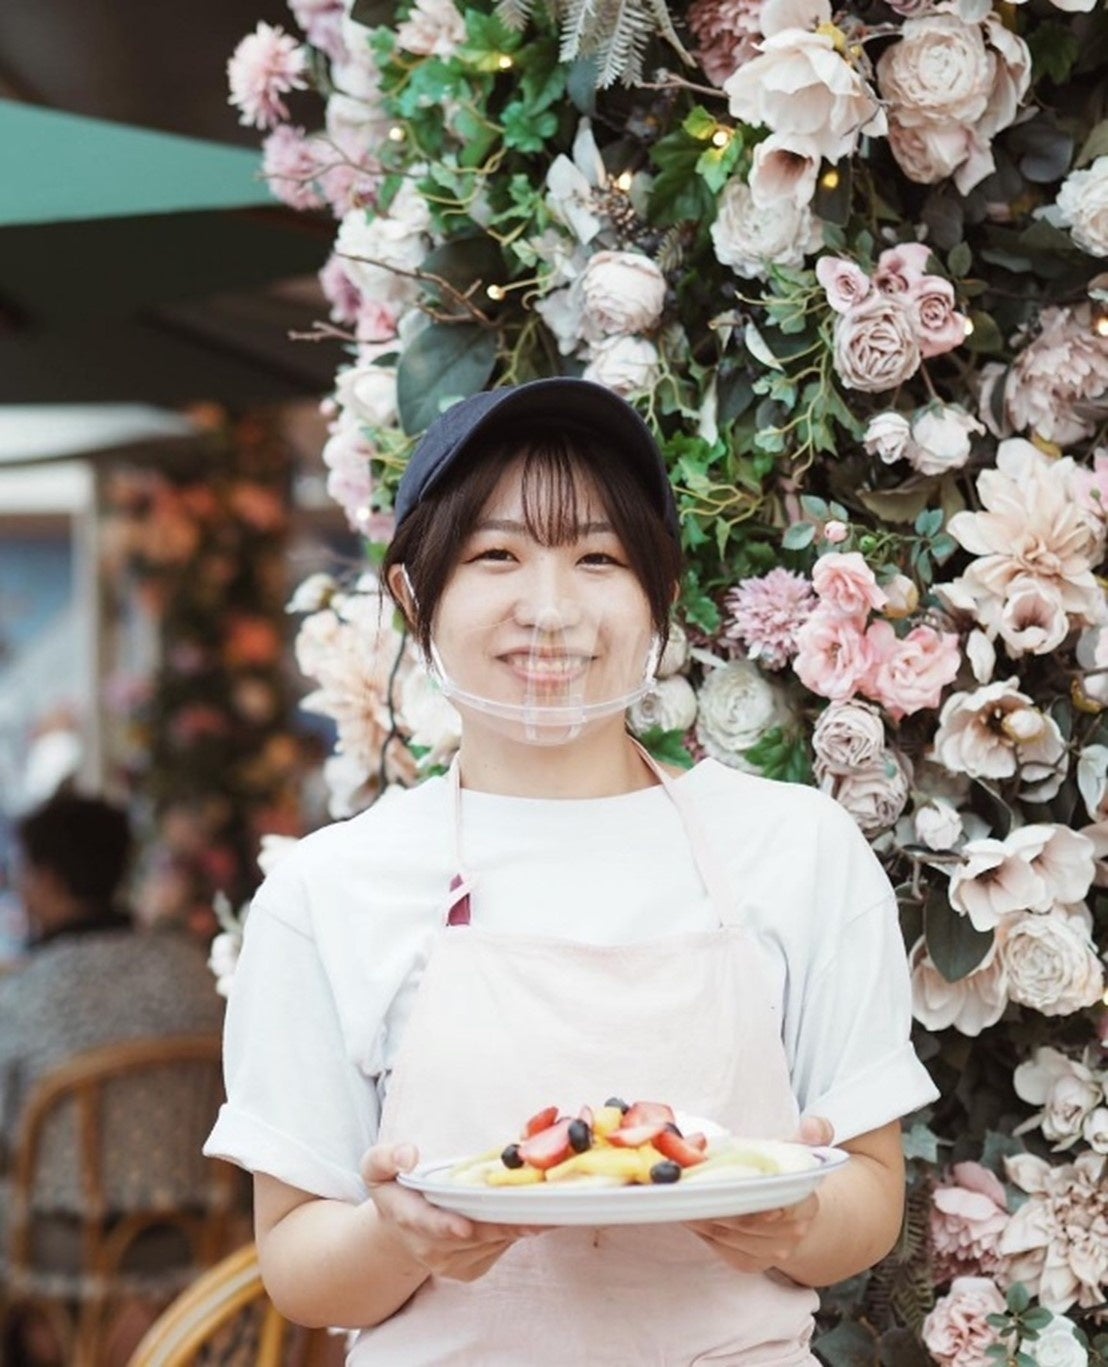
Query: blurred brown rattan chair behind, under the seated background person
[{"left": 0, "top": 1033, "right": 242, "bottom": 1367}]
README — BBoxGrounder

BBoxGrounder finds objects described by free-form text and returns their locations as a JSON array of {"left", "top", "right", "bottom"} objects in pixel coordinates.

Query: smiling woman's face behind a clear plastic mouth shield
[{"left": 432, "top": 461, "right": 652, "bottom": 718}]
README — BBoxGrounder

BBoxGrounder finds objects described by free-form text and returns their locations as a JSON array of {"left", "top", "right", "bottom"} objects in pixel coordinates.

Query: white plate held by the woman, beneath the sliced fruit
[{"left": 399, "top": 1148, "right": 850, "bottom": 1225}]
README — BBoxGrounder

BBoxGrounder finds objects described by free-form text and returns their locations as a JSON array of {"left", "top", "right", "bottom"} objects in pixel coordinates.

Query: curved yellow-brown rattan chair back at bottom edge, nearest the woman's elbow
[{"left": 128, "top": 1244, "right": 343, "bottom": 1367}]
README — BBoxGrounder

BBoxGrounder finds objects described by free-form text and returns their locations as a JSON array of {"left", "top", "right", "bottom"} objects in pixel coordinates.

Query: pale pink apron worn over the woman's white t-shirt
[{"left": 360, "top": 759, "right": 817, "bottom": 1367}]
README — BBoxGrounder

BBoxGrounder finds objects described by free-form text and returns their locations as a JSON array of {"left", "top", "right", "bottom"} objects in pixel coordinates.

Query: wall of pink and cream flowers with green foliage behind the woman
[{"left": 230, "top": 0, "right": 1108, "bottom": 1367}]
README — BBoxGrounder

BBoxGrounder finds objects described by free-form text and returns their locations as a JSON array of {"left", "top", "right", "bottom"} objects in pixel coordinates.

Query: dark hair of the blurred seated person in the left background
[{"left": 16, "top": 797, "right": 131, "bottom": 908}]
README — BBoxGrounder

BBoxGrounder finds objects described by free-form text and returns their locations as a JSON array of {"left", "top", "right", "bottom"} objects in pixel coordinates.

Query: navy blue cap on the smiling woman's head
[{"left": 393, "top": 376, "right": 680, "bottom": 541}]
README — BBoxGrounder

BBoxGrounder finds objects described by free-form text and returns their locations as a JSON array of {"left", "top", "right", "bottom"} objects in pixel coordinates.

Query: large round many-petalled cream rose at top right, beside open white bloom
[{"left": 877, "top": 14, "right": 995, "bottom": 126}]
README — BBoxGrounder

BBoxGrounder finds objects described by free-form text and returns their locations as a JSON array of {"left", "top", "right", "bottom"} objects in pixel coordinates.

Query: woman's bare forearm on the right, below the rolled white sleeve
[{"left": 776, "top": 1154, "right": 904, "bottom": 1286}]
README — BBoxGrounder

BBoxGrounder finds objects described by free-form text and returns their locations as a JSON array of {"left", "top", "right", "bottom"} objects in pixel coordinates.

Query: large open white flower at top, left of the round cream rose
[{"left": 723, "top": 27, "right": 885, "bottom": 161}]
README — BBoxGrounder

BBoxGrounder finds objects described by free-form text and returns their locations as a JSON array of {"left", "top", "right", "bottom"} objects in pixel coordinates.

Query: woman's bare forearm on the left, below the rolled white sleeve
[{"left": 258, "top": 1199, "right": 428, "bottom": 1329}]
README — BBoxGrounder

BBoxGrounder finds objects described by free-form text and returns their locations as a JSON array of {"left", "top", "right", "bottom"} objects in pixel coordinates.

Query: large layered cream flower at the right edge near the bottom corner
[{"left": 1000, "top": 1154, "right": 1108, "bottom": 1312}]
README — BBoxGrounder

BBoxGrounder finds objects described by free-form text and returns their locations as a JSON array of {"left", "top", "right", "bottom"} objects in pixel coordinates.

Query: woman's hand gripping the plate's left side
[{"left": 362, "top": 1144, "right": 541, "bottom": 1281}]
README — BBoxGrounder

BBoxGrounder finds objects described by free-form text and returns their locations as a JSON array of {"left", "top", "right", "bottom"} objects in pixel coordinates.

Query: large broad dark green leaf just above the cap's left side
[{"left": 396, "top": 323, "right": 496, "bottom": 436}]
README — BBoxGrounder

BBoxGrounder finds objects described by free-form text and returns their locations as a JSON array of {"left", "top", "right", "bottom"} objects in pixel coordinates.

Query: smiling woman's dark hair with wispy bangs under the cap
[{"left": 381, "top": 422, "right": 682, "bottom": 651}]
